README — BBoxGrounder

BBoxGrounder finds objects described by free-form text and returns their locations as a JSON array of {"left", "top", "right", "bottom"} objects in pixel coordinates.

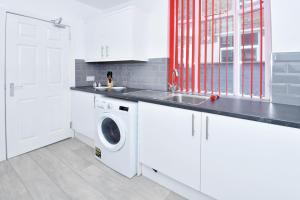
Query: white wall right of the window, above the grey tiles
[{"left": 271, "top": 0, "right": 300, "bottom": 52}]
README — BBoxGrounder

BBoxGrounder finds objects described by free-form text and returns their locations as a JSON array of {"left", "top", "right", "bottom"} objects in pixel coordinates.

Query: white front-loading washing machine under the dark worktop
[{"left": 95, "top": 97, "right": 138, "bottom": 178}]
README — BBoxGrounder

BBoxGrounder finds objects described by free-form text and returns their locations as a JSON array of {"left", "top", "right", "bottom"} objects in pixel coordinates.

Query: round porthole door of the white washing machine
[{"left": 98, "top": 113, "right": 126, "bottom": 151}]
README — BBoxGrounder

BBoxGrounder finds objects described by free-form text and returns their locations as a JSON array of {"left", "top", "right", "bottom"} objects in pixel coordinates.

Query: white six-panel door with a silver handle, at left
[{"left": 6, "top": 14, "right": 70, "bottom": 158}]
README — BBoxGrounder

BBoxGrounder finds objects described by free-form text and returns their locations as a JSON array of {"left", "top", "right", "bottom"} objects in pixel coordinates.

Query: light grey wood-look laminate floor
[{"left": 0, "top": 139, "right": 183, "bottom": 200}]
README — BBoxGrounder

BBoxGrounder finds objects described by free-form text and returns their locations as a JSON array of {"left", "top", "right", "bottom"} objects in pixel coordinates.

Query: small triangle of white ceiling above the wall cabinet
[{"left": 77, "top": 0, "right": 130, "bottom": 10}]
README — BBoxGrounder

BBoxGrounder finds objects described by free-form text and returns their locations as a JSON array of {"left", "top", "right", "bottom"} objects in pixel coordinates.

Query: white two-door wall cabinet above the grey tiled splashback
[{"left": 86, "top": 6, "right": 147, "bottom": 62}]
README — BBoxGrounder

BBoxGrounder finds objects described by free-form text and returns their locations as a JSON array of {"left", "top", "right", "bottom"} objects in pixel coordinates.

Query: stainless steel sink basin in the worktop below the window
[{"left": 163, "top": 94, "right": 208, "bottom": 105}]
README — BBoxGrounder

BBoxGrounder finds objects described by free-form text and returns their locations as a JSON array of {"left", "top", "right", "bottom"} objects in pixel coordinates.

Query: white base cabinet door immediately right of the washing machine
[{"left": 139, "top": 103, "right": 201, "bottom": 190}]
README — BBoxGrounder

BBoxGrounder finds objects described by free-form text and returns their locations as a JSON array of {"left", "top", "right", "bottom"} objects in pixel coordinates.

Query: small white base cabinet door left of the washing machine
[{"left": 71, "top": 91, "right": 96, "bottom": 139}]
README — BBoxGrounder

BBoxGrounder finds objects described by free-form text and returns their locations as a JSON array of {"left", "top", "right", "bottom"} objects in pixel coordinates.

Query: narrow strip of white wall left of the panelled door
[{"left": 0, "top": 7, "right": 6, "bottom": 161}]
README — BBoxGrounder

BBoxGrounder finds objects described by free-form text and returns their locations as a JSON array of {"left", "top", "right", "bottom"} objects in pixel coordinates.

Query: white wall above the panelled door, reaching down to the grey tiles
[{"left": 0, "top": 0, "right": 100, "bottom": 58}]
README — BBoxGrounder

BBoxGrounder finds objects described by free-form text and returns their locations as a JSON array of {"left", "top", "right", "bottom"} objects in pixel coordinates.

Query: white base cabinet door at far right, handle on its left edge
[{"left": 201, "top": 114, "right": 300, "bottom": 200}]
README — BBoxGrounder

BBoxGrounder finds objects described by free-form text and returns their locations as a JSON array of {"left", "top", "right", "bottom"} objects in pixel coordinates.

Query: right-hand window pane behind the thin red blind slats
[{"left": 239, "top": 0, "right": 265, "bottom": 96}]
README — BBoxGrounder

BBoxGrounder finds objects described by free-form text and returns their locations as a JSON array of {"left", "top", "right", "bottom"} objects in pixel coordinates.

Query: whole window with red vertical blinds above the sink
[{"left": 169, "top": 0, "right": 269, "bottom": 98}]
